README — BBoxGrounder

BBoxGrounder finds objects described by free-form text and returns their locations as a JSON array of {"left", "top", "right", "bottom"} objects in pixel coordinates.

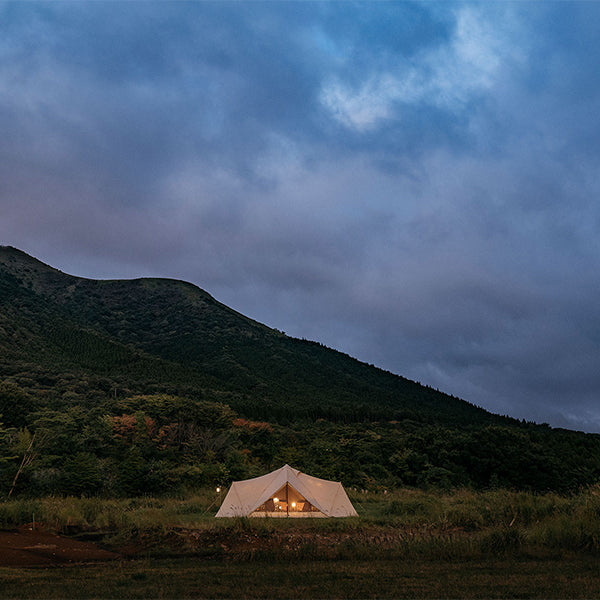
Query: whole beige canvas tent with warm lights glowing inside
[{"left": 216, "top": 465, "right": 358, "bottom": 517}]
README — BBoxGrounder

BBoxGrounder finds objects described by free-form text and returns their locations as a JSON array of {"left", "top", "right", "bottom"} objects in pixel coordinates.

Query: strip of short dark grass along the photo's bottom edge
[{"left": 0, "top": 557, "right": 600, "bottom": 599}]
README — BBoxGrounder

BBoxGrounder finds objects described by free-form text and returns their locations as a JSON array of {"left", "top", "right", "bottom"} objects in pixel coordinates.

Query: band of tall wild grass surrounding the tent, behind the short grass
[{"left": 0, "top": 486, "right": 600, "bottom": 560}]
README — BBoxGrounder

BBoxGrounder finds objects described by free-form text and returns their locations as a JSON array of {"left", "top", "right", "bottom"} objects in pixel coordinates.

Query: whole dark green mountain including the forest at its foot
[{"left": 0, "top": 246, "right": 600, "bottom": 496}]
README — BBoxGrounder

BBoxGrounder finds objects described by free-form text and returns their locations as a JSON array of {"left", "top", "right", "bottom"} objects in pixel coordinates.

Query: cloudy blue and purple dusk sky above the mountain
[{"left": 0, "top": 1, "right": 600, "bottom": 432}]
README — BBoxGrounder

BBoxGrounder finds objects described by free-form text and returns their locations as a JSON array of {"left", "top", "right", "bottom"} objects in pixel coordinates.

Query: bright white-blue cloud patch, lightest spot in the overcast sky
[{"left": 321, "top": 5, "right": 521, "bottom": 133}]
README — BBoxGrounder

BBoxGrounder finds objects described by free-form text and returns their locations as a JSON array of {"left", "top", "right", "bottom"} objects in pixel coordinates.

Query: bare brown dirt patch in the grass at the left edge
[{"left": 0, "top": 524, "right": 119, "bottom": 567}]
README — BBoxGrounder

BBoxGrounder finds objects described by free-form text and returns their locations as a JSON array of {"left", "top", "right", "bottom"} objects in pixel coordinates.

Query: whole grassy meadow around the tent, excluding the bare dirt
[{"left": 0, "top": 486, "right": 600, "bottom": 598}]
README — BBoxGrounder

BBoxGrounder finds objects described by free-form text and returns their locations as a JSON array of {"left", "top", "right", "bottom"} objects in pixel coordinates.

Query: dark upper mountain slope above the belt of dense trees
[{"left": 0, "top": 246, "right": 501, "bottom": 423}]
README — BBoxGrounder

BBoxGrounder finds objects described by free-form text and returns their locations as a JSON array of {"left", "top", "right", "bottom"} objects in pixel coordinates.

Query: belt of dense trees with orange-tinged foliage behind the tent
[{"left": 0, "top": 384, "right": 600, "bottom": 496}]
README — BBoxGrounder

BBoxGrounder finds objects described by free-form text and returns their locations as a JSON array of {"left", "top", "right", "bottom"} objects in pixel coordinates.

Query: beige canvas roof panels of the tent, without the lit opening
[{"left": 216, "top": 465, "right": 357, "bottom": 517}]
